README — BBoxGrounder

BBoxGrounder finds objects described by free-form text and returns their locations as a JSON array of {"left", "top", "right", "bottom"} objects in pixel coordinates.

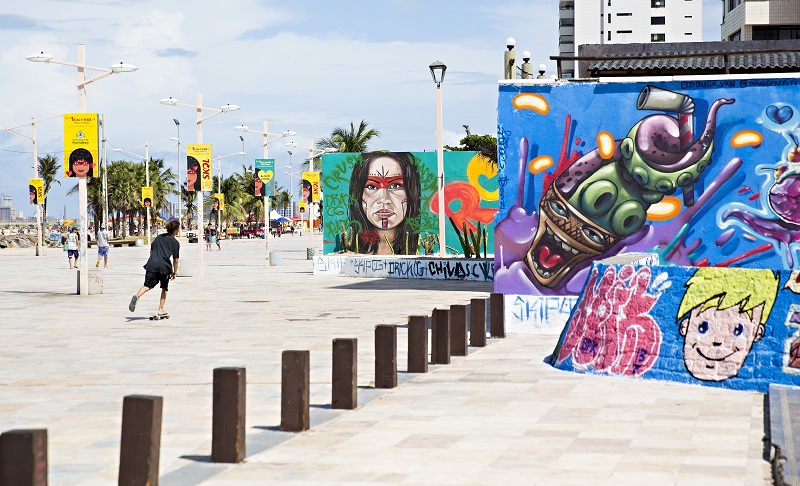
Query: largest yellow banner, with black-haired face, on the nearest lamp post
[{"left": 64, "top": 113, "right": 100, "bottom": 177}]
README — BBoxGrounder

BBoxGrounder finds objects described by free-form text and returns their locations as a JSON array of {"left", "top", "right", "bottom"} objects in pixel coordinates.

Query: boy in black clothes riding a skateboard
[{"left": 128, "top": 221, "right": 181, "bottom": 319}]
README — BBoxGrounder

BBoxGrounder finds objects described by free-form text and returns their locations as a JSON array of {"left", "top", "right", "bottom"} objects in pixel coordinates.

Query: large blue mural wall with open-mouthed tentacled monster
[{"left": 495, "top": 78, "right": 800, "bottom": 295}]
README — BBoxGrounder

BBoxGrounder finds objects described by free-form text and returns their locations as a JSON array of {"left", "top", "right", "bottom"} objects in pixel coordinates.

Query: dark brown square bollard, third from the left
[{"left": 211, "top": 368, "right": 247, "bottom": 463}]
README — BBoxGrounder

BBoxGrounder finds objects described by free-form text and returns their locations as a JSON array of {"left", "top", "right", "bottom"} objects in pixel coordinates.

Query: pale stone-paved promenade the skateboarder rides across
[{"left": 0, "top": 235, "right": 771, "bottom": 486}]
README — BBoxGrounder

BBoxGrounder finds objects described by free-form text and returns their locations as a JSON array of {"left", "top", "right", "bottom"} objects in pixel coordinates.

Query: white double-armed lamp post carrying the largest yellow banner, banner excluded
[{"left": 25, "top": 44, "right": 139, "bottom": 295}]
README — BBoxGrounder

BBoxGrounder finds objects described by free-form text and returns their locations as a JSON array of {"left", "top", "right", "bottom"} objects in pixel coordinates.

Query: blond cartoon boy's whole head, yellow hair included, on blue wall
[{"left": 676, "top": 267, "right": 780, "bottom": 381}]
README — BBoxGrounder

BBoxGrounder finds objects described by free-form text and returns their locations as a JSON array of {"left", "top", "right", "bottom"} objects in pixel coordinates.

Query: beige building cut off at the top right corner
[{"left": 721, "top": 0, "right": 800, "bottom": 41}]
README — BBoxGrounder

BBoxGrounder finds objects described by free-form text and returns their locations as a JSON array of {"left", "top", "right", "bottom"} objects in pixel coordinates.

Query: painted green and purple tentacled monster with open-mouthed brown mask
[{"left": 525, "top": 86, "right": 735, "bottom": 288}]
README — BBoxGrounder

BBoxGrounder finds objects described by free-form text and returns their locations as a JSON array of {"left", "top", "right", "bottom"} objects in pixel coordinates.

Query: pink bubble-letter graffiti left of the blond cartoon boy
[{"left": 558, "top": 265, "right": 661, "bottom": 375}]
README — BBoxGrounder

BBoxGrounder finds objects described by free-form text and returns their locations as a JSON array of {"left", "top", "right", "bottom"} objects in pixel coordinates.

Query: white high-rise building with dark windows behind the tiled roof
[{"left": 558, "top": 0, "right": 704, "bottom": 78}]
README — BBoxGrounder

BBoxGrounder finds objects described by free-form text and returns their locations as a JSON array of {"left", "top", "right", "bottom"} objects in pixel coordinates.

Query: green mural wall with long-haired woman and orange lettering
[{"left": 322, "top": 152, "right": 498, "bottom": 256}]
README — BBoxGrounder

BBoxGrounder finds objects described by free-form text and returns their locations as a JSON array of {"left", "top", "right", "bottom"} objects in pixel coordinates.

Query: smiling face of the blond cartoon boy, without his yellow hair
[{"left": 680, "top": 304, "right": 764, "bottom": 381}]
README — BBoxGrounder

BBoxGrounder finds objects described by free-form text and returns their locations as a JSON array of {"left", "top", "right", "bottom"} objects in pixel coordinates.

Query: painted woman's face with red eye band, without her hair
[{"left": 361, "top": 157, "right": 408, "bottom": 230}]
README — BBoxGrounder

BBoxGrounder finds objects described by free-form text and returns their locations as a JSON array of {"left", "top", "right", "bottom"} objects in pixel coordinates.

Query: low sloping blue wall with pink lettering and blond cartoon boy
[{"left": 551, "top": 264, "right": 800, "bottom": 392}]
